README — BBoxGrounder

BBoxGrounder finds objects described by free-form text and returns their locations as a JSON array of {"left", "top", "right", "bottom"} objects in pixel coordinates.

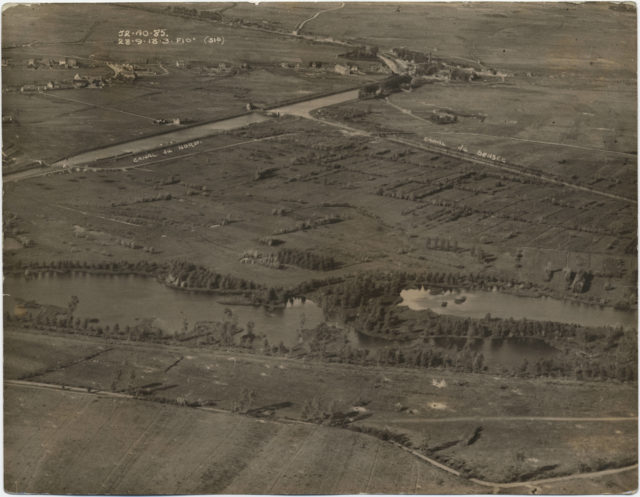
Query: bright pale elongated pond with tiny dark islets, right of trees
[{"left": 400, "top": 288, "right": 638, "bottom": 329}]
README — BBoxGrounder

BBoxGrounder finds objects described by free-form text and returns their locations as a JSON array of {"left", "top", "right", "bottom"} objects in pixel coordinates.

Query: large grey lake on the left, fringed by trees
[{"left": 3, "top": 273, "right": 324, "bottom": 347}]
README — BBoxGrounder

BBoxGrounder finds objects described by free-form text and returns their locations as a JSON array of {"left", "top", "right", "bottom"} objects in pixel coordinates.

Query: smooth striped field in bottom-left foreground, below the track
[{"left": 5, "top": 380, "right": 484, "bottom": 494}]
